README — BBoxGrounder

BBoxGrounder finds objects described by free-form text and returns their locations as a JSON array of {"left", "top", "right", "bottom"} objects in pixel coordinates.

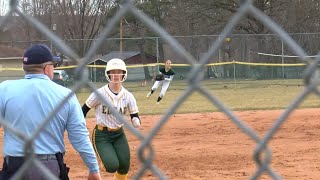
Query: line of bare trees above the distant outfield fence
[{"left": 0, "top": 0, "right": 320, "bottom": 56}]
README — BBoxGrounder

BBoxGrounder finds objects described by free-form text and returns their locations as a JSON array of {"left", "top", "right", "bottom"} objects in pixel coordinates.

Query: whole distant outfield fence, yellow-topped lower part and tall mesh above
[{"left": 0, "top": 33, "right": 320, "bottom": 82}]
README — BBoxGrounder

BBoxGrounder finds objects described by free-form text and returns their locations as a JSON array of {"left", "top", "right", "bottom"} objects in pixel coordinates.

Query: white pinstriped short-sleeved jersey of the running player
[{"left": 86, "top": 85, "right": 139, "bottom": 128}]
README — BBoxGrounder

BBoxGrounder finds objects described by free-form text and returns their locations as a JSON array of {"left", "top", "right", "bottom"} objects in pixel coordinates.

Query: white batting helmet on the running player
[{"left": 105, "top": 58, "right": 128, "bottom": 82}]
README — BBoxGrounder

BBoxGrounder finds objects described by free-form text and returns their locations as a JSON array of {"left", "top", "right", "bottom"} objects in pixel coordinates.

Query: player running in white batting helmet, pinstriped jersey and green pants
[{"left": 82, "top": 59, "right": 141, "bottom": 180}]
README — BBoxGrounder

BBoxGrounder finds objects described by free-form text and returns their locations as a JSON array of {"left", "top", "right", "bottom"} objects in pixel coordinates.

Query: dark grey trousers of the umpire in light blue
[{"left": 0, "top": 154, "right": 60, "bottom": 180}]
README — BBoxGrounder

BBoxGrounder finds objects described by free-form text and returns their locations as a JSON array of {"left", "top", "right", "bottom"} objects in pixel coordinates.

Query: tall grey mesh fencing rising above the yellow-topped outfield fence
[{"left": 0, "top": 33, "right": 320, "bottom": 64}]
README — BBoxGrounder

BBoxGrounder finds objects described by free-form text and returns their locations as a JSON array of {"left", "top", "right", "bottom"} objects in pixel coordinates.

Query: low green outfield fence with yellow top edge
[{"left": 0, "top": 58, "right": 307, "bottom": 84}]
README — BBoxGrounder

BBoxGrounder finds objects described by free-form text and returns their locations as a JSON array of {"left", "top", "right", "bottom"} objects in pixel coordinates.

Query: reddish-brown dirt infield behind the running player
[{"left": 1, "top": 109, "right": 320, "bottom": 180}]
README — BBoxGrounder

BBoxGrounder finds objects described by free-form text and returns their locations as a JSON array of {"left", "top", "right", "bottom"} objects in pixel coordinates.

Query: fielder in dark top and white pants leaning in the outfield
[{"left": 147, "top": 60, "right": 175, "bottom": 104}]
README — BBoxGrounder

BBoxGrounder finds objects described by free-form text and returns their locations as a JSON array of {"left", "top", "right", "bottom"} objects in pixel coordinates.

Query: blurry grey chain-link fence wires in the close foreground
[{"left": 0, "top": 0, "right": 320, "bottom": 179}]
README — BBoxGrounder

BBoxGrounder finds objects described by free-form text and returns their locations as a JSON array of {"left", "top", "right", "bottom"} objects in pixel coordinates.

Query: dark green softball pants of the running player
[{"left": 92, "top": 127, "right": 130, "bottom": 174}]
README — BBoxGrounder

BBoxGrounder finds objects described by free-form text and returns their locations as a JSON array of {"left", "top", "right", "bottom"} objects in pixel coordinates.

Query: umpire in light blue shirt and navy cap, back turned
[{"left": 0, "top": 44, "right": 101, "bottom": 180}]
